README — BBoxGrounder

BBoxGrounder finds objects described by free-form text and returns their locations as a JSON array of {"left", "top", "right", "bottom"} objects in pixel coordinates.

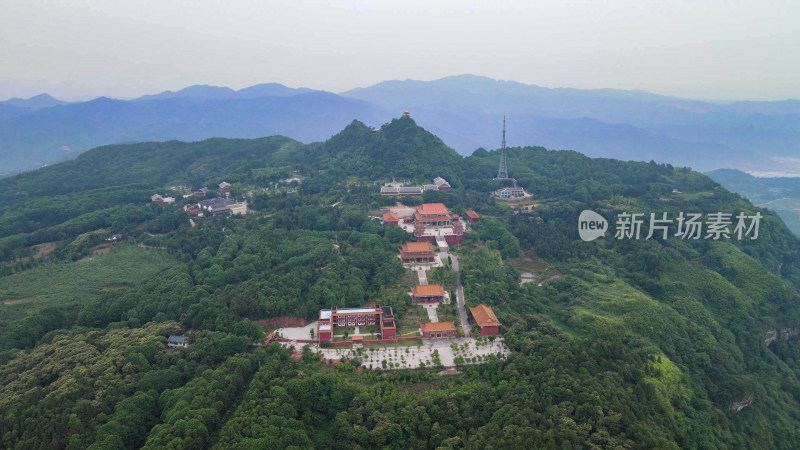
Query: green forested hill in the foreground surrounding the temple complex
[{"left": 0, "top": 119, "right": 800, "bottom": 449}]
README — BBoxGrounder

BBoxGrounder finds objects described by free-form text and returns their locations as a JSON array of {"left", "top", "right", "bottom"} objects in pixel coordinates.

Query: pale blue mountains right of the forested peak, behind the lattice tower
[{"left": 342, "top": 75, "right": 800, "bottom": 170}]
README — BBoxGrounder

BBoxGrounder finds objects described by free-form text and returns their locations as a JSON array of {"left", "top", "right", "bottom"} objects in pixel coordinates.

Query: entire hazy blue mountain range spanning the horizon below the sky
[{"left": 0, "top": 75, "right": 800, "bottom": 173}]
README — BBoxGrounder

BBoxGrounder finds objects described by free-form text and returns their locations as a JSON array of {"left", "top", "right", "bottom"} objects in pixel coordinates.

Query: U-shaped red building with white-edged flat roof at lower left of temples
[{"left": 317, "top": 306, "right": 397, "bottom": 342}]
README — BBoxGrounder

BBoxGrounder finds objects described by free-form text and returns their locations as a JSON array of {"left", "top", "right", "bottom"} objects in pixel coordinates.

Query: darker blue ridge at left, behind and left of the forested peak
[{"left": 0, "top": 85, "right": 386, "bottom": 173}]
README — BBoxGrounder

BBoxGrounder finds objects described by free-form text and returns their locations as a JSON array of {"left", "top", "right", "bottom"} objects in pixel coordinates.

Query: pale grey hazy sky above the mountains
[{"left": 0, "top": 0, "right": 800, "bottom": 100}]
